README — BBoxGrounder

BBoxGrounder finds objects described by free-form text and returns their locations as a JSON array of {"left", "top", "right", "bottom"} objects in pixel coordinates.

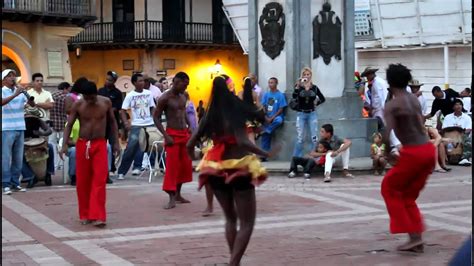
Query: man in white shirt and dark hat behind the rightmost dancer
[{"left": 361, "top": 67, "right": 388, "bottom": 130}]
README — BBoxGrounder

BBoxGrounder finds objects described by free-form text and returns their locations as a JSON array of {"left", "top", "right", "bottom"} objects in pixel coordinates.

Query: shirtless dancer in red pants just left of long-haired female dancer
[{"left": 153, "top": 72, "right": 193, "bottom": 209}]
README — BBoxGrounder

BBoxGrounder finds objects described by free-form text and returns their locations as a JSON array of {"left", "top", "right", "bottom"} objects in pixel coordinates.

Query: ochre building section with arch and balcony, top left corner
[{"left": 2, "top": 0, "right": 96, "bottom": 87}]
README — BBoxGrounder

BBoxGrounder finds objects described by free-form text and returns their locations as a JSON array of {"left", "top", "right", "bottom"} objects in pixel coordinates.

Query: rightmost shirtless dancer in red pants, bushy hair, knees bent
[{"left": 382, "top": 64, "right": 436, "bottom": 252}]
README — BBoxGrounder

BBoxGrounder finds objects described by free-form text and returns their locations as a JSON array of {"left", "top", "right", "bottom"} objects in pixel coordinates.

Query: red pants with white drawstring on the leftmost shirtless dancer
[{"left": 76, "top": 139, "right": 109, "bottom": 221}]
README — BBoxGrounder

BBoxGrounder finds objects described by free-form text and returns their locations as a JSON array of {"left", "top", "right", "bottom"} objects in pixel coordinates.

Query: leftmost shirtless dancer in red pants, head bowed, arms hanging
[{"left": 59, "top": 82, "right": 119, "bottom": 227}]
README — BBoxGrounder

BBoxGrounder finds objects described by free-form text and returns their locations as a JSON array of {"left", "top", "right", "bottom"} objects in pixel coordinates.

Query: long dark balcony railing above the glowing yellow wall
[{"left": 69, "top": 21, "right": 238, "bottom": 44}]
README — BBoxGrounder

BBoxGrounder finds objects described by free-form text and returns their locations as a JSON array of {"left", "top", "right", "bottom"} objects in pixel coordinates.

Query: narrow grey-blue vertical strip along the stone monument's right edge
[{"left": 343, "top": 0, "right": 356, "bottom": 94}]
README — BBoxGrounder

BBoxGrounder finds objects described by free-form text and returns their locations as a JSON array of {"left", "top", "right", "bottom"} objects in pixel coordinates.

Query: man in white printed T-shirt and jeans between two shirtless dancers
[{"left": 118, "top": 74, "right": 156, "bottom": 180}]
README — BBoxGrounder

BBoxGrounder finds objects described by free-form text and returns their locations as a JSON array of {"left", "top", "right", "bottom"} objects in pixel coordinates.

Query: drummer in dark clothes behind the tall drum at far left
[{"left": 21, "top": 107, "right": 54, "bottom": 188}]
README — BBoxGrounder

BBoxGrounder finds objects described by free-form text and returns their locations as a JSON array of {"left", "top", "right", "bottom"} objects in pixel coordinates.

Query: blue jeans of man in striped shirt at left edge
[{"left": 2, "top": 130, "right": 25, "bottom": 188}]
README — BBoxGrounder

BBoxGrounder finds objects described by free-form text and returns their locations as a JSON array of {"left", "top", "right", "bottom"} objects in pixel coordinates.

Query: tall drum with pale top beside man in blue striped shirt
[{"left": 25, "top": 138, "right": 49, "bottom": 179}]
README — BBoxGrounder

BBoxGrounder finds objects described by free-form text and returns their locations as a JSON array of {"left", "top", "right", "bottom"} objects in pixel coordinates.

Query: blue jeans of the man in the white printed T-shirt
[{"left": 117, "top": 126, "right": 143, "bottom": 175}]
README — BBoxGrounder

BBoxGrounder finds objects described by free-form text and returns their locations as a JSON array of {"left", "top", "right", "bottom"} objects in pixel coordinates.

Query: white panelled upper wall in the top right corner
[{"left": 356, "top": 0, "right": 472, "bottom": 48}]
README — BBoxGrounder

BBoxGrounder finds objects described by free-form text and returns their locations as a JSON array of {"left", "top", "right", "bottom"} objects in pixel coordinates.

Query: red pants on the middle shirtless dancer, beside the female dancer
[{"left": 163, "top": 128, "right": 193, "bottom": 192}]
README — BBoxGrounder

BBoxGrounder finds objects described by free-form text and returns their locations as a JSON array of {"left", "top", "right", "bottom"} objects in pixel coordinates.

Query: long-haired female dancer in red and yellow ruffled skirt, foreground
[{"left": 187, "top": 76, "right": 273, "bottom": 265}]
